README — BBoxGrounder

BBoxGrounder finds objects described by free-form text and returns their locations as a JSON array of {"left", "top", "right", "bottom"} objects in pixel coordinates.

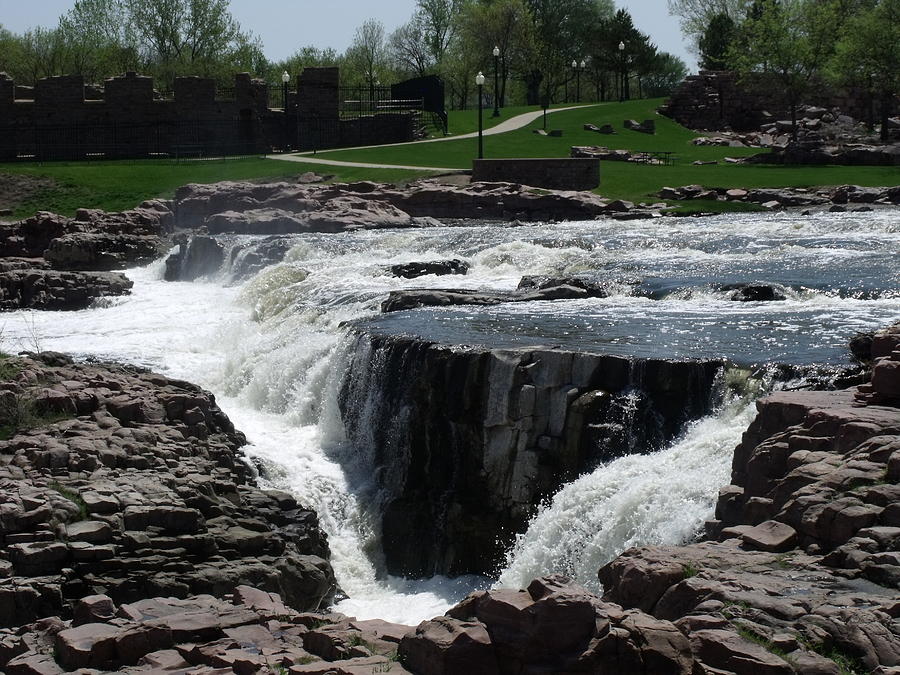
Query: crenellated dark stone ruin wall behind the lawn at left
[{"left": 0, "top": 68, "right": 414, "bottom": 161}]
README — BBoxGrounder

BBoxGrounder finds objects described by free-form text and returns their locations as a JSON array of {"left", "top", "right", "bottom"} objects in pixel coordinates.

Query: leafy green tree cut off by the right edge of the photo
[{"left": 832, "top": 0, "right": 900, "bottom": 142}]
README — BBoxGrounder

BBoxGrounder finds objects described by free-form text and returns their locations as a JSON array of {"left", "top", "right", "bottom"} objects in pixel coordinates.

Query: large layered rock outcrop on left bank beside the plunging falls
[{"left": 0, "top": 353, "right": 335, "bottom": 628}]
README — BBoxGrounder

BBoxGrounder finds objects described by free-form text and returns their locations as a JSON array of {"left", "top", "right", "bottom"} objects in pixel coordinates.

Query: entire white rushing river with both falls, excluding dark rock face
[{"left": 2, "top": 214, "right": 900, "bottom": 623}]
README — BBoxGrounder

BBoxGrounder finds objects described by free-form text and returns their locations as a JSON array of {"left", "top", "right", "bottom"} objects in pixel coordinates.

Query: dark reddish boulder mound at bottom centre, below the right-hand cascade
[{"left": 400, "top": 576, "right": 694, "bottom": 675}]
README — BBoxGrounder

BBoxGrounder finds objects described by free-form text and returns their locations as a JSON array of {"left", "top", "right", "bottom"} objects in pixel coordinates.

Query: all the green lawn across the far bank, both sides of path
[{"left": 0, "top": 99, "right": 900, "bottom": 218}]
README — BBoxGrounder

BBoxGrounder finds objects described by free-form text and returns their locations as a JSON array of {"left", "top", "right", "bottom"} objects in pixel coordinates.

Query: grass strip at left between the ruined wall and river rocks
[{"left": 0, "top": 159, "right": 422, "bottom": 218}]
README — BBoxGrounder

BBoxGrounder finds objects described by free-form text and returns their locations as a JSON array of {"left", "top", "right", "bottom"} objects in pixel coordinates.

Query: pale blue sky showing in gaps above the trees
[{"left": 0, "top": 0, "right": 697, "bottom": 70}]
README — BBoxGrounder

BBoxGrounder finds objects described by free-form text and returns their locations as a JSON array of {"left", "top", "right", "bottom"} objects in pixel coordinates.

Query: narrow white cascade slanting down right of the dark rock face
[{"left": 498, "top": 398, "right": 755, "bottom": 591}]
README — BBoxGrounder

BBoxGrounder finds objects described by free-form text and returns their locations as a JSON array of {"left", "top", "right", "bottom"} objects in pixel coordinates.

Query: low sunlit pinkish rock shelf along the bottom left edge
[{"left": 0, "top": 586, "right": 413, "bottom": 675}]
